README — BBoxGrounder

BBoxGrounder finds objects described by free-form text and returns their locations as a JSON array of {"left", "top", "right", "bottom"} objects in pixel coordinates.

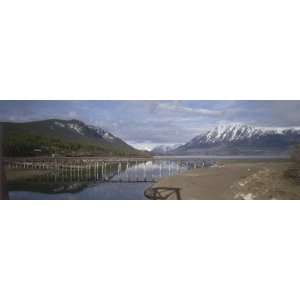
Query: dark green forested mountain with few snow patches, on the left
[{"left": 1, "top": 119, "right": 149, "bottom": 156}]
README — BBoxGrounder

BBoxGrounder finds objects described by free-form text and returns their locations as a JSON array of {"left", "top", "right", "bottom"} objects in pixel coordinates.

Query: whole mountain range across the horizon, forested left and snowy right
[{"left": 0, "top": 119, "right": 300, "bottom": 157}]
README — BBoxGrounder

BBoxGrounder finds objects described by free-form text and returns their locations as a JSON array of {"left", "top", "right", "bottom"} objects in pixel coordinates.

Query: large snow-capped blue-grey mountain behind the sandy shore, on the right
[{"left": 169, "top": 124, "right": 300, "bottom": 155}]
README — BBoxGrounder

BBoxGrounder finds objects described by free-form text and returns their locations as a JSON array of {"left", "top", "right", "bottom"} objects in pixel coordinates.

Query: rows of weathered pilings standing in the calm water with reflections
[{"left": 6, "top": 158, "right": 213, "bottom": 182}]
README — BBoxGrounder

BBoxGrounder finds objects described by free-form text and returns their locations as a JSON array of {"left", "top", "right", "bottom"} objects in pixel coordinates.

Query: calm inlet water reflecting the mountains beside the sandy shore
[{"left": 9, "top": 158, "right": 212, "bottom": 200}]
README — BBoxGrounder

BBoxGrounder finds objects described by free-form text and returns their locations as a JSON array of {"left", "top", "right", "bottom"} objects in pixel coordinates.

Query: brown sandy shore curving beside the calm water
[{"left": 145, "top": 161, "right": 300, "bottom": 200}]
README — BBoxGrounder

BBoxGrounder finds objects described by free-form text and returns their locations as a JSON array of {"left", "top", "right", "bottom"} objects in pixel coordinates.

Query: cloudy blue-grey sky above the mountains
[{"left": 0, "top": 100, "right": 300, "bottom": 150}]
